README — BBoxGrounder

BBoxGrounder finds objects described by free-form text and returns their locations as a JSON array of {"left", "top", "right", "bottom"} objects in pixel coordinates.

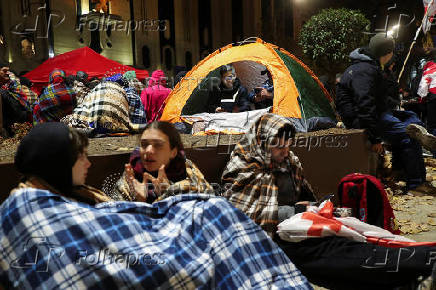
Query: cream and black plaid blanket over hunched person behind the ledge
[{"left": 70, "top": 81, "right": 145, "bottom": 134}]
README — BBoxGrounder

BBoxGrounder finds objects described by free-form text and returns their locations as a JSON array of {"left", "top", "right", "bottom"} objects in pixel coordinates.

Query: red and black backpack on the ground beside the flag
[{"left": 338, "top": 173, "right": 401, "bottom": 234}]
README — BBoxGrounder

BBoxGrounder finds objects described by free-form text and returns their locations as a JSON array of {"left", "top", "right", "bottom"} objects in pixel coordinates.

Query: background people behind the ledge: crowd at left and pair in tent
[{"left": 0, "top": 59, "right": 280, "bottom": 135}]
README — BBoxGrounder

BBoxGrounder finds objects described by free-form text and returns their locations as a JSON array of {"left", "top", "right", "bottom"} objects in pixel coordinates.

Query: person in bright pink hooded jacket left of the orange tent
[{"left": 141, "top": 70, "right": 171, "bottom": 123}]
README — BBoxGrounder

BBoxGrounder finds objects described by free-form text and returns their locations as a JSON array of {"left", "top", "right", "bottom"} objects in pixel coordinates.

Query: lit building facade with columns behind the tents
[{"left": 0, "top": 0, "right": 307, "bottom": 73}]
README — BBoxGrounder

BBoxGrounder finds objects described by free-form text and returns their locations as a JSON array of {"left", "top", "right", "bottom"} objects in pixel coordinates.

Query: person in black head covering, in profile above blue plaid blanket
[{"left": 15, "top": 122, "right": 110, "bottom": 204}]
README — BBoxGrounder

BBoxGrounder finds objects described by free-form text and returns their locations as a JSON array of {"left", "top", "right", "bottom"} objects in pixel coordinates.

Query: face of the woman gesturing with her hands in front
[{"left": 140, "top": 129, "right": 177, "bottom": 172}]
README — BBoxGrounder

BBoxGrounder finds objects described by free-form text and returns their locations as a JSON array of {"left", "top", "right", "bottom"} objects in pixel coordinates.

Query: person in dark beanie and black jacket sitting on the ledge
[{"left": 336, "top": 33, "right": 436, "bottom": 192}]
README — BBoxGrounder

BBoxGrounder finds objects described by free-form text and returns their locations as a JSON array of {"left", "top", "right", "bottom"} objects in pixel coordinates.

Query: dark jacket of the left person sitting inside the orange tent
[{"left": 207, "top": 78, "right": 250, "bottom": 113}]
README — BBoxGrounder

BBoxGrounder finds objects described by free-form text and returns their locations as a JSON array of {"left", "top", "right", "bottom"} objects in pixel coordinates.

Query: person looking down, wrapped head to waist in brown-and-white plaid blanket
[{"left": 222, "top": 114, "right": 316, "bottom": 236}]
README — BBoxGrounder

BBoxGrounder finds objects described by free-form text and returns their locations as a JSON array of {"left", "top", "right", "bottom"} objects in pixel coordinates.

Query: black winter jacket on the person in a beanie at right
[{"left": 336, "top": 48, "right": 388, "bottom": 144}]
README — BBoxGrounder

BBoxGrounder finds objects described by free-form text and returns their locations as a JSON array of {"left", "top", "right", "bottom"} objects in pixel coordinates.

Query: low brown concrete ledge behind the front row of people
[{"left": 0, "top": 130, "right": 376, "bottom": 201}]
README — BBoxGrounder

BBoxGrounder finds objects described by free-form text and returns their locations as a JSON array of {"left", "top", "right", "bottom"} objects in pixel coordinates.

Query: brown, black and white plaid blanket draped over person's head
[{"left": 222, "top": 114, "right": 315, "bottom": 236}]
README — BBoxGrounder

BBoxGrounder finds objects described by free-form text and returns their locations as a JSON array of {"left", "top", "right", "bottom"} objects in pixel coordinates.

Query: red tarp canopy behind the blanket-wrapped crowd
[{"left": 24, "top": 47, "right": 148, "bottom": 92}]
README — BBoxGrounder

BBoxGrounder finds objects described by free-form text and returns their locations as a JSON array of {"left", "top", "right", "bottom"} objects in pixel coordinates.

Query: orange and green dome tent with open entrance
[{"left": 161, "top": 38, "right": 336, "bottom": 123}]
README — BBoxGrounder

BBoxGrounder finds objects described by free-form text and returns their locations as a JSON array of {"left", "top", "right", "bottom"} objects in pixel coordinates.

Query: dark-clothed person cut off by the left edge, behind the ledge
[{"left": 0, "top": 64, "right": 32, "bottom": 135}]
